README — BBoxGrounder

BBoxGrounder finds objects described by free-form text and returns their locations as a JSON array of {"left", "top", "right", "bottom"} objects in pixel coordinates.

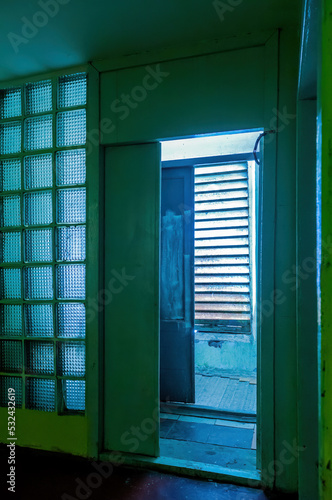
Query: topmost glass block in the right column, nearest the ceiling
[{"left": 58, "top": 73, "right": 87, "bottom": 108}]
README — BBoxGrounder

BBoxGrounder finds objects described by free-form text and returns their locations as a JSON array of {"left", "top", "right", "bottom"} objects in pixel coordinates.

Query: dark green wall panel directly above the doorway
[{"left": 100, "top": 47, "right": 264, "bottom": 144}]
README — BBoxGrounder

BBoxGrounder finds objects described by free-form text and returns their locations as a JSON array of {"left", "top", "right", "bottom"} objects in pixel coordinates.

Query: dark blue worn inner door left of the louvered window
[{"left": 160, "top": 167, "right": 195, "bottom": 403}]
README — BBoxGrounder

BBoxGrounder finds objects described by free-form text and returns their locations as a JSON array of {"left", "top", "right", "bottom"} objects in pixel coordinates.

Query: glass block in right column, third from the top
[{"left": 55, "top": 149, "right": 86, "bottom": 186}]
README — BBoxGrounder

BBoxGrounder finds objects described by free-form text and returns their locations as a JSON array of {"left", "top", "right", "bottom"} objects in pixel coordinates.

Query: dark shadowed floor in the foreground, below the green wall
[{"left": 0, "top": 447, "right": 296, "bottom": 500}]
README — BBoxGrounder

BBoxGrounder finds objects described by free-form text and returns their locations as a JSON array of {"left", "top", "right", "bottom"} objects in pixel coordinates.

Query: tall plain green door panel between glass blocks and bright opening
[{"left": 104, "top": 143, "right": 160, "bottom": 456}]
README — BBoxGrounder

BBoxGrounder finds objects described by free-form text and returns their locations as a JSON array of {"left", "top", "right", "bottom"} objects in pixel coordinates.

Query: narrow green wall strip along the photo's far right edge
[{"left": 318, "top": 0, "right": 332, "bottom": 500}]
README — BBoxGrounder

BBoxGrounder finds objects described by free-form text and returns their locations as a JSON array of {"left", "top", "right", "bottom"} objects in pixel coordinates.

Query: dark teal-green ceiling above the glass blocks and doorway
[{"left": 0, "top": 0, "right": 301, "bottom": 80}]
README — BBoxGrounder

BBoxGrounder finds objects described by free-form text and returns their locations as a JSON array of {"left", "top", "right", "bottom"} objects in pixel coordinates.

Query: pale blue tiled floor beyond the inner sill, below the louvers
[{"left": 195, "top": 375, "right": 257, "bottom": 414}]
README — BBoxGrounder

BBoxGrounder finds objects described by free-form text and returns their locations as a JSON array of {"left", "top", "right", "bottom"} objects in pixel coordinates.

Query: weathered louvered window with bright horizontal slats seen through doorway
[{"left": 195, "top": 162, "right": 251, "bottom": 333}]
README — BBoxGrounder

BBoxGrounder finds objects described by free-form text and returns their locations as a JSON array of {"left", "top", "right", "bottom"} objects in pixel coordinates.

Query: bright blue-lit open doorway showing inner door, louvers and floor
[{"left": 160, "top": 131, "right": 260, "bottom": 465}]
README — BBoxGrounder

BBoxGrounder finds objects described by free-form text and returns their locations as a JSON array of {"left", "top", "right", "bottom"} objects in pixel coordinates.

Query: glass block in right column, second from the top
[{"left": 56, "top": 109, "right": 86, "bottom": 147}]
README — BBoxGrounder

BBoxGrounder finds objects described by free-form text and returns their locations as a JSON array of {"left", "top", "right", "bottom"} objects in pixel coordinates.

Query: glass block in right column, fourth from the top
[{"left": 56, "top": 188, "right": 86, "bottom": 224}]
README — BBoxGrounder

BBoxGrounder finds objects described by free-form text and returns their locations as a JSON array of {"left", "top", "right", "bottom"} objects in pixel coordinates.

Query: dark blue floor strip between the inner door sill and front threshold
[{"left": 160, "top": 413, "right": 256, "bottom": 450}]
